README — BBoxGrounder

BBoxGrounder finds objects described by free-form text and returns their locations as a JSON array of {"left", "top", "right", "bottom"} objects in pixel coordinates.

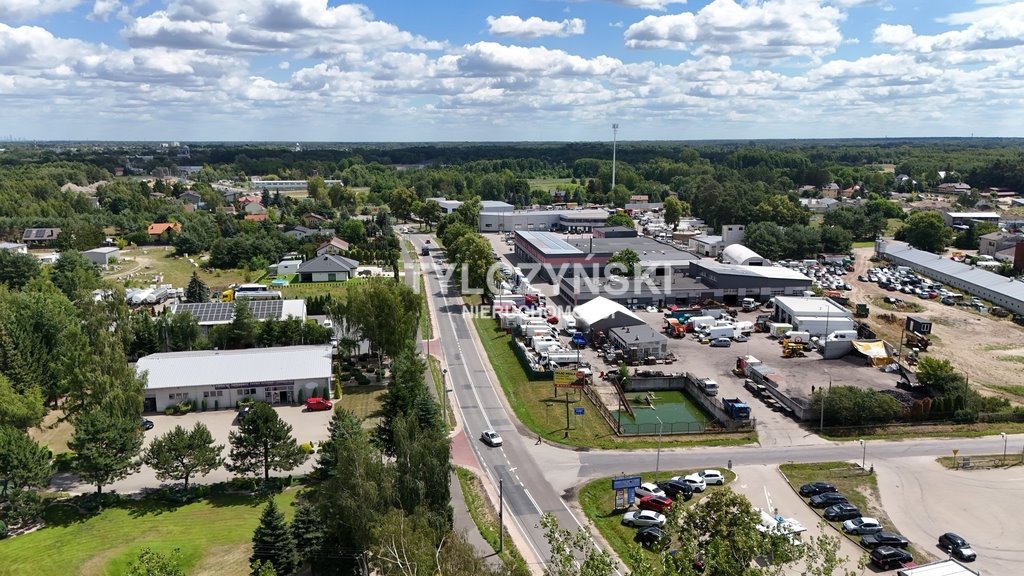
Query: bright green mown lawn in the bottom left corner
[{"left": 0, "top": 488, "right": 299, "bottom": 576}]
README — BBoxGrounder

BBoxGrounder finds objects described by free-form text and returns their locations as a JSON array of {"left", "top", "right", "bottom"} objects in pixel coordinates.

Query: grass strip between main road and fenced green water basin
[{"left": 474, "top": 318, "right": 757, "bottom": 448}]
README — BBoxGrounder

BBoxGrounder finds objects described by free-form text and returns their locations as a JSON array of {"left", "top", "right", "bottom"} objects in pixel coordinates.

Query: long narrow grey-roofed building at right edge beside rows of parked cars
[{"left": 874, "top": 240, "right": 1024, "bottom": 314}]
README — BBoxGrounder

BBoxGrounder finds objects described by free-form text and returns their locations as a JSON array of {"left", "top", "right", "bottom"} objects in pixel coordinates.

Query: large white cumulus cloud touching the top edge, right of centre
[{"left": 626, "top": 0, "right": 845, "bottom": 59}]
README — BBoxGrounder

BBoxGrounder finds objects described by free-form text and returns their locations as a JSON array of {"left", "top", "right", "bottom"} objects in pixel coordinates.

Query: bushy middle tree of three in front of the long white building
[{"left": 142, "top": 422, "right": 224, "bottom": 489}]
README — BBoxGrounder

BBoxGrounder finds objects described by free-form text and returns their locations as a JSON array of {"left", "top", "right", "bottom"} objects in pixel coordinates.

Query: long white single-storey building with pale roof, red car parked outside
[{"left": 135, "top": 344, "right": 332, "bottom": 412}]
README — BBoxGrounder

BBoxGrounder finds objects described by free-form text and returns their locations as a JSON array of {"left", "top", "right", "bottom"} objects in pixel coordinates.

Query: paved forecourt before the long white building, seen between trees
[{"left": 52, "top": 406, "right": 332, "bottom": 493}]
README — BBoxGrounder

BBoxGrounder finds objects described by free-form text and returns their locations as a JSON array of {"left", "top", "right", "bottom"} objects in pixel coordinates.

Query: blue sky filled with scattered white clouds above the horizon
[{"left": 0, "top": 0, "right": 1024, "bottom": 141}]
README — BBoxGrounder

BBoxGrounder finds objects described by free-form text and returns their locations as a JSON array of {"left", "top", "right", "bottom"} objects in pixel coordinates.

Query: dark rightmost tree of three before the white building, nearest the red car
[{"left": 227, "top": 402, "right": 306, "bottom": 481}]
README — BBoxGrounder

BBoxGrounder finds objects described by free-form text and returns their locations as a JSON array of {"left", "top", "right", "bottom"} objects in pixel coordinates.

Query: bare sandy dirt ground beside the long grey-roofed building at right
[{"left": 848, "top": 248, "right": 1024, "bottom": 402}]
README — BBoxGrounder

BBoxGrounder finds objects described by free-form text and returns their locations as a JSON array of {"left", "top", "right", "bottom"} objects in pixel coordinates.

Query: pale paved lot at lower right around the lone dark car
[{"left": 876, "top": 455, "right": 1024, "bottom": 574}]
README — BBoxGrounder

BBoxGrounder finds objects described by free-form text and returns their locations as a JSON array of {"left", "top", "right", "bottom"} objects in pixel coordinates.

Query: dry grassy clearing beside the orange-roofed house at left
[{"left": 105, "top": 246, "right": 253, "bottom": 293}]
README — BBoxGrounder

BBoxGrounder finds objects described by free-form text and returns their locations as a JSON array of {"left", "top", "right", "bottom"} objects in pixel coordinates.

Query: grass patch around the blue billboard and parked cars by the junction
[{"left": 580, "top": 470, "right": 736, "bottom": 568}]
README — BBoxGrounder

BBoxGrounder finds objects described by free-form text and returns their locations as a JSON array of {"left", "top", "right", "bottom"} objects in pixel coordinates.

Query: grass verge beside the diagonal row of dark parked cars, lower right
[{"left": 779, "top": 462, "right": 934, "bottom": 564}]
